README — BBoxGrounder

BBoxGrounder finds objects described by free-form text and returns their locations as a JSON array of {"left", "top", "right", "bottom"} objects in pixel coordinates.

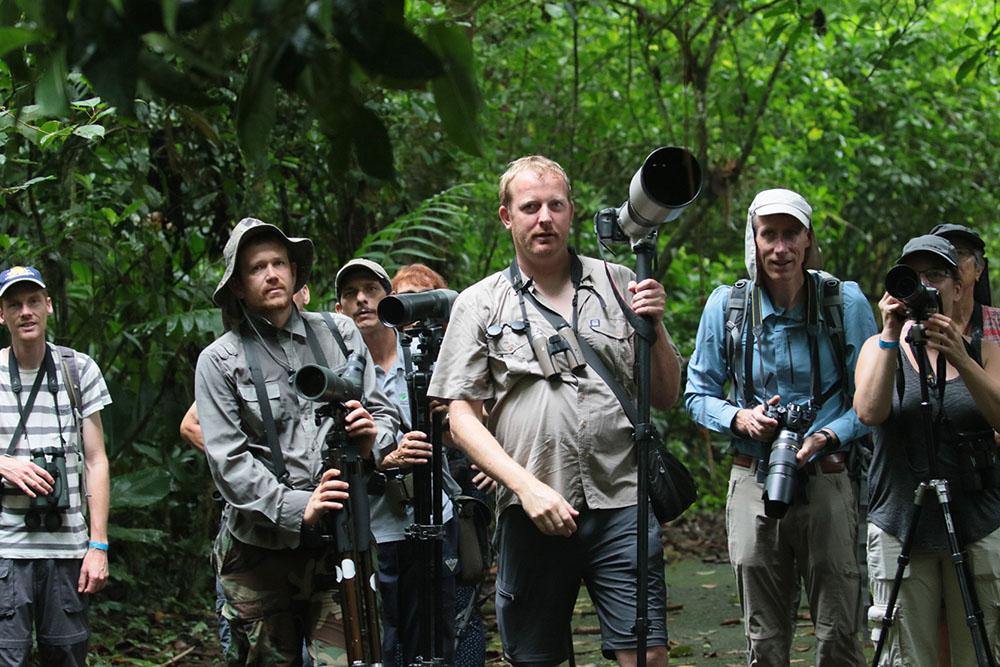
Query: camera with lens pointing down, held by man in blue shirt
[{"left": 764, "top": 402, "right": 816, "bottom": 519}]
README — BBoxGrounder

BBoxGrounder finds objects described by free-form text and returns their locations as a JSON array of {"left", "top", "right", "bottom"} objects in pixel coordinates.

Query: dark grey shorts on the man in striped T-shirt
[{"left": 0, "top": 558, "right": 90, "bottom": 648}]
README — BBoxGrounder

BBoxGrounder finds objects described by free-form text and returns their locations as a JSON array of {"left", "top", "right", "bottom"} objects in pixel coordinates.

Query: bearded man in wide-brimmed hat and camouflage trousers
[{"left": 195, "top": 218, "right": 397, "bottom": 665}]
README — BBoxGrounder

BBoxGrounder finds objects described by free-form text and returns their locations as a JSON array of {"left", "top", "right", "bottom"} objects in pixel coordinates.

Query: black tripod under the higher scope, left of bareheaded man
[{"left": 401, "top": 324, "right": 445, "bottom": 666}]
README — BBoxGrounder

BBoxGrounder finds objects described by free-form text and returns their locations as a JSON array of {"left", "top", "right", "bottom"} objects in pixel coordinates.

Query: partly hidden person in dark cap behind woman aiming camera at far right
[{"left": 931, "top": 224, "right": 1000, "bottom": 345}]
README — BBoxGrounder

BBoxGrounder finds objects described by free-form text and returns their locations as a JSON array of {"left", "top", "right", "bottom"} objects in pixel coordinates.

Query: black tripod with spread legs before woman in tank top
[{"left": 872, "top": 322, "right": 996, "bottom": 667}]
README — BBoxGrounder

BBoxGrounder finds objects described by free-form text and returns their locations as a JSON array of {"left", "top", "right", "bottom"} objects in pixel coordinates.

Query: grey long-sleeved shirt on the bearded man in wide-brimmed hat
[{"left": 195, "top": 312, "right": 398, "bottom": 549}]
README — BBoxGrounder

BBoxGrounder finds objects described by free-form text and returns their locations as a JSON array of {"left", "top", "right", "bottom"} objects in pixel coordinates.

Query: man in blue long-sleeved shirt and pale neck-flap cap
[{"left": 685, "top": 189, "right": 876, "bottom": 667}]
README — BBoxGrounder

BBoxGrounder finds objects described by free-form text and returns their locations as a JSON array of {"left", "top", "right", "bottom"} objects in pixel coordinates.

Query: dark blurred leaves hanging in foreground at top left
[{"left": 0, "top": 0, "right": 480, "bottom": 178}]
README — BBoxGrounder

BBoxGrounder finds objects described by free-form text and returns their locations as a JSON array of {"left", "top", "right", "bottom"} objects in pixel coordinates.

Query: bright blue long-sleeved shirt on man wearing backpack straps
[{"left": 684, "top": 281, "right": 877, "bottom": 456}]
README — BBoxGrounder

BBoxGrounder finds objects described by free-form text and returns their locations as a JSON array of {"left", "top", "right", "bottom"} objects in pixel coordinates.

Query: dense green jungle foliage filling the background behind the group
[{"left": 0, "top": 0, "right": 1000, "bottom": 655}]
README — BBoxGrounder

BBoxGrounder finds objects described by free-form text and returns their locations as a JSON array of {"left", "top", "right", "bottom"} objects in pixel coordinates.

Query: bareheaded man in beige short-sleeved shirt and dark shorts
[{"left": 428, "top": 155, "right": 680, "bottom": 665}]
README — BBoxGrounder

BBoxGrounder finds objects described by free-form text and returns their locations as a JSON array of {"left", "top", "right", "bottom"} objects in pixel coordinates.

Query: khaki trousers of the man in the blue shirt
[{"left": 726, "top": 466, "right": 865, "bottom": 667}]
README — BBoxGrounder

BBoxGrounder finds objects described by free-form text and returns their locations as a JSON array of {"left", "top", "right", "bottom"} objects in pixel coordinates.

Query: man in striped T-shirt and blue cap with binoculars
[{"left": 0, "top": 266, "right": 111, "bottom": 667}]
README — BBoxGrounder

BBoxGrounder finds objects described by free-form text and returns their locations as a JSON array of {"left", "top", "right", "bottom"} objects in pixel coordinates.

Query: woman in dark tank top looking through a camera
[{"left": 854, "top": 234, "right": 1000, "bottom": 667}]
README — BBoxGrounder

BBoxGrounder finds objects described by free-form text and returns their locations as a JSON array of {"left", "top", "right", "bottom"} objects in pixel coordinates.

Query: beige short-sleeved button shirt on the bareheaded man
[{"left": 428, "top": 257, "right": 648, "bottom": 512}]
